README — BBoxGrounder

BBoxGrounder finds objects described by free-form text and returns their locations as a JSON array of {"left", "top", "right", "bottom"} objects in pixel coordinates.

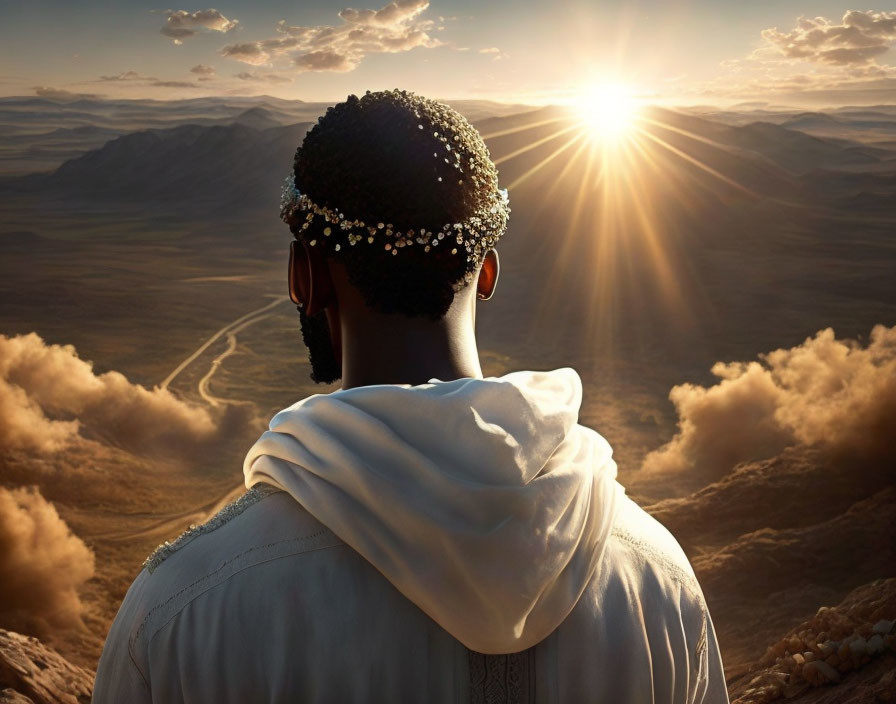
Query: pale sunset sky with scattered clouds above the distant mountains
[{"left": 0, "top": 0, "right": 896, "bottom": 106}]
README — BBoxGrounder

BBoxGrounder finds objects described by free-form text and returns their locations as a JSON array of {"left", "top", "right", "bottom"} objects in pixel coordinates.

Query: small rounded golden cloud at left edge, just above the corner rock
[{"left": 0, "top": 487, "right": 94, "bottom": 635}]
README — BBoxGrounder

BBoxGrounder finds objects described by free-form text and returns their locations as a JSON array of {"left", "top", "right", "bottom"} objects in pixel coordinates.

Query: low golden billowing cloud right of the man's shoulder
[{"left": 643, "top": 325, "right": 896, "bottom": 480}]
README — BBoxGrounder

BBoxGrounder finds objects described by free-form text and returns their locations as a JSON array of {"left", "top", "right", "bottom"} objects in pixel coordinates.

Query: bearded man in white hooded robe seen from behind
[{"left": 94, "top": 91, "right": 728, "bottom": 704}]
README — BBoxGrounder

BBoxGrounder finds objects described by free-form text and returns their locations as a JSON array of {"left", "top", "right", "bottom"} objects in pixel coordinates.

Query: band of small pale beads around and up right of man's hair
[{"left": 280, "top": 91, "right": 510, "bottom": 288}]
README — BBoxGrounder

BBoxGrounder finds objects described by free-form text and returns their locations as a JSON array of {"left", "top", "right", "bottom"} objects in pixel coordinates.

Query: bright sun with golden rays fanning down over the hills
[{"left": 485, "top": 89, "right": 755, "bottom": 352}]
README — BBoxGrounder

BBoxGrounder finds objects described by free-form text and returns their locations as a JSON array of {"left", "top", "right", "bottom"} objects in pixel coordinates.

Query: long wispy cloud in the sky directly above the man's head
[{"left": 220, "top": 0, "right": 443, "bottom": 72}]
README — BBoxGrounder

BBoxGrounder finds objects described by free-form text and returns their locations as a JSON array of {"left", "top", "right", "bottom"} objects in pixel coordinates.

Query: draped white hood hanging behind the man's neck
[{"left": 243, "top": 368, "right": 624, "bottom": 653}]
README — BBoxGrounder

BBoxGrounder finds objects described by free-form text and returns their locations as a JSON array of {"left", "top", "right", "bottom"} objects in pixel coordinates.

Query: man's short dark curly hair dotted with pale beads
[{"left": 282, "top": 90, "right": 509, "bottom": 319}]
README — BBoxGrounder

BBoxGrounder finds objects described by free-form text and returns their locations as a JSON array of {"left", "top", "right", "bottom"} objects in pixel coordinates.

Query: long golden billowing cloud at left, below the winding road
[{"left": 0, "top": 333, "right": 245, "bottom": 456}]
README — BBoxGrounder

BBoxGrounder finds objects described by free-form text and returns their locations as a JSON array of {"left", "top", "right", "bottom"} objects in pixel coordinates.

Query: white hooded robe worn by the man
[{"left": 94, "top": 368, "right": 728, "bottom": 703}]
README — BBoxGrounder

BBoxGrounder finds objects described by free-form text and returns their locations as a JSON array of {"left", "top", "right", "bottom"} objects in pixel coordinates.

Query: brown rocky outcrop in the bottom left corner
[{"left": 0, "top": 628, "right": 93, "bottom": 704}]
